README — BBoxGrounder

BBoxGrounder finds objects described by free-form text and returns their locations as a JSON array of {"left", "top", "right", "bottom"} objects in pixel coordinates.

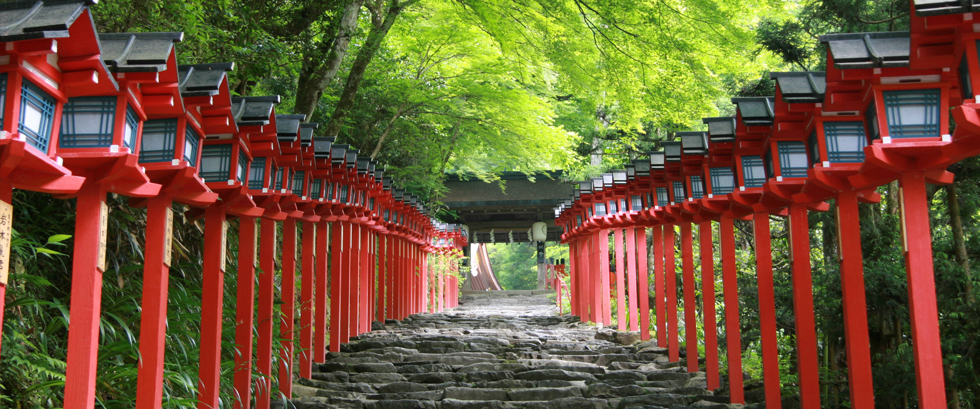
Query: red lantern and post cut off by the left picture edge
[{"left": 0, "top": 1, "right": 98, "bottom": 356}]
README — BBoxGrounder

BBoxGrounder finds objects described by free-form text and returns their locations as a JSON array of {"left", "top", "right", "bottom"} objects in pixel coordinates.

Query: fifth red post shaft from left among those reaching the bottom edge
[{"left": 255, "top": 219, "right": 280, "bottom": 409}]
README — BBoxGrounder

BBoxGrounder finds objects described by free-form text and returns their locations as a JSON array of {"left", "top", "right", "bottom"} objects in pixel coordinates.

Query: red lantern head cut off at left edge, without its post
[{"left": 0, "top": 1, "right": 118, "bottom": 163}]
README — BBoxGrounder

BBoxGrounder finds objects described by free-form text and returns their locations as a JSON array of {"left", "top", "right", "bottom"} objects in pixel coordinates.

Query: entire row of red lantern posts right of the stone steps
[{"left": 555, "top": 0, "right": 980, "bottom": 408}]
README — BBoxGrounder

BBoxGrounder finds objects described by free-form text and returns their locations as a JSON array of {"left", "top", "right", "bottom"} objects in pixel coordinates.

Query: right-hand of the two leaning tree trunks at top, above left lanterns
[{"left": 324, "top": 1, "right": 415, "bottom": 137}]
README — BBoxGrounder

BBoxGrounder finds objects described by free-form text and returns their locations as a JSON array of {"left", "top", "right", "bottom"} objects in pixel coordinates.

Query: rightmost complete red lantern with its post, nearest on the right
[{"left": 821, "top": 27, "right": 964, "bottom": 408}]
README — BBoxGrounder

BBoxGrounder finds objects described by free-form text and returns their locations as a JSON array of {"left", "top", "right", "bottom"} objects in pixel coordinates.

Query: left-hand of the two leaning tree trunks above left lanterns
[{"left": 294, "top": 0, "right": 364, "bottom": 121}]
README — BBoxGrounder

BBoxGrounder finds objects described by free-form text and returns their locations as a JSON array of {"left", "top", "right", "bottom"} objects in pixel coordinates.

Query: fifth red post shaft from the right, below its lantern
[{"left": 720, "top": 217, "right": 745, "bottom": 404}]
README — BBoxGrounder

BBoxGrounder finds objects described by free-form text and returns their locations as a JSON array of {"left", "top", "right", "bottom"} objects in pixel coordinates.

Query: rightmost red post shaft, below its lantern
[{"left": 899, "top": 172, "right": 946, "bottom": 409}]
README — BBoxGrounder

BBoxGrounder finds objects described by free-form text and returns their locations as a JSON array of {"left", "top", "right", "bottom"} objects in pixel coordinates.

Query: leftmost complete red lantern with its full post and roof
[{"left": 57, "top": 29, "right": 194, "bottom": 408}]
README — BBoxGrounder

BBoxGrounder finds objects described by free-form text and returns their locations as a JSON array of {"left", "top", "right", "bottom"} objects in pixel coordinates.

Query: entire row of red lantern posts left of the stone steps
[{"left": 0, "top": 0, "right": 466, "bottom": 408}]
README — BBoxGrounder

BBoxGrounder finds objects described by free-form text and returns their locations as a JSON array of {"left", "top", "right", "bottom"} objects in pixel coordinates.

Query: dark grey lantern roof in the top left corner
[{"left": 0, "top": 0, "right": 96, "bottom": 42}]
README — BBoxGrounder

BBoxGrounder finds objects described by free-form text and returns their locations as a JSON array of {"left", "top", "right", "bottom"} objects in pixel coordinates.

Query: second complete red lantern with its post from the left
[{"left": 130, "top": 60, "right": 234, "bottom": 408}]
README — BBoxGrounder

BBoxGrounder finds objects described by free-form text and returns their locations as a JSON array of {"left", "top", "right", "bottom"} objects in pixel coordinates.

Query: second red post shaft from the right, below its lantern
[{"left": 837, "top": 191, "right": 875, "bottom": 409}]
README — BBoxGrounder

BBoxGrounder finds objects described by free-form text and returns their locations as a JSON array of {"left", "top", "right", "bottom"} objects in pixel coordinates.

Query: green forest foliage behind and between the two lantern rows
[{"left": 0, "top": 0, "right": 980, "bottom": 408}]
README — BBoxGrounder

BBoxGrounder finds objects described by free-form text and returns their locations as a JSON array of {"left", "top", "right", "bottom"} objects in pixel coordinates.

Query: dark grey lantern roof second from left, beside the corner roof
[{"left": 99, "top": 32, "right": 184, "bottom": 73}]
